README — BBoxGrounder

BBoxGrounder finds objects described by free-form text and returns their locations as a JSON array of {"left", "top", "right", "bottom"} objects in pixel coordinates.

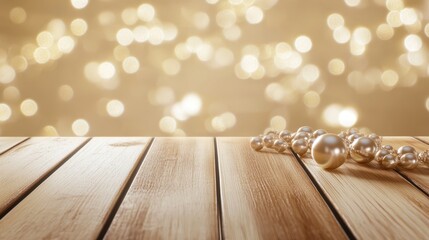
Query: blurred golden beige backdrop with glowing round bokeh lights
[{"left": 0, "top": 0, "right": 429, "bottom": 136}]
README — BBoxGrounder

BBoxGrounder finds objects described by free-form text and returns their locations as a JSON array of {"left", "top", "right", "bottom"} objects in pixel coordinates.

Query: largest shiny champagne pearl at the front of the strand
[{"left": 311, "top": 133, "right": 347, "bottom": 169}]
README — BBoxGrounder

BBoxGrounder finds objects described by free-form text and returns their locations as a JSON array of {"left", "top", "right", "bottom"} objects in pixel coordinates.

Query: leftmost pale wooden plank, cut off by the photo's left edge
[{"left": 0, "top": 137, "right": 87, "bottom": 218}]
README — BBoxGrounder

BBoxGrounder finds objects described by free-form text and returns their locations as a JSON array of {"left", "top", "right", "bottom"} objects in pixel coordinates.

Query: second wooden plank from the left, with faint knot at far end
[{"left": 0, "top": 138, "right": 149, "bottom": 239}]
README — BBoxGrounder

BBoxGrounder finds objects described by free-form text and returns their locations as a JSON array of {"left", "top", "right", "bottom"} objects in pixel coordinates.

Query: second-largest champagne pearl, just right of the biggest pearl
[{"left": 350, "top": 137, "right": 377, "bottom": 163}]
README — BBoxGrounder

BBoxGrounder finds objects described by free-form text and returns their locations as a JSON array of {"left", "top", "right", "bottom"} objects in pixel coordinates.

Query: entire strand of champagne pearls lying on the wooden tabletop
[{"left": 250, "top": 126, "right": 429, "bottom": 169}]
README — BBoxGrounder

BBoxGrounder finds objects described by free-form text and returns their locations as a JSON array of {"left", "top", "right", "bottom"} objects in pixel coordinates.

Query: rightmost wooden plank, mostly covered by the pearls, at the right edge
[{"left": 383, "top": 137, "right": 429, "bottom": 194}]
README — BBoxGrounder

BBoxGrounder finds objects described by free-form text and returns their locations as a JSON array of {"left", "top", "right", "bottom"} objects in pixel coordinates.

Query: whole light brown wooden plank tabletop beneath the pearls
[{"left": 0, "top": 137, "right": 429, "bottom": 239}]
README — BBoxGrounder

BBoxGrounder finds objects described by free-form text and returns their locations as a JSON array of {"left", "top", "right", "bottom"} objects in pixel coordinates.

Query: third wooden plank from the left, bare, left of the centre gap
[{"left": 106, "top": 138, "right": 218, "bottom": 239}]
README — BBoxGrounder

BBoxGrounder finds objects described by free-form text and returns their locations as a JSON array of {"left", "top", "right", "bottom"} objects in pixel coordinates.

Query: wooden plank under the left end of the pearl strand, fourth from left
[{"left": 217, "top": 138, "right": 347, "bottom": 239}]
